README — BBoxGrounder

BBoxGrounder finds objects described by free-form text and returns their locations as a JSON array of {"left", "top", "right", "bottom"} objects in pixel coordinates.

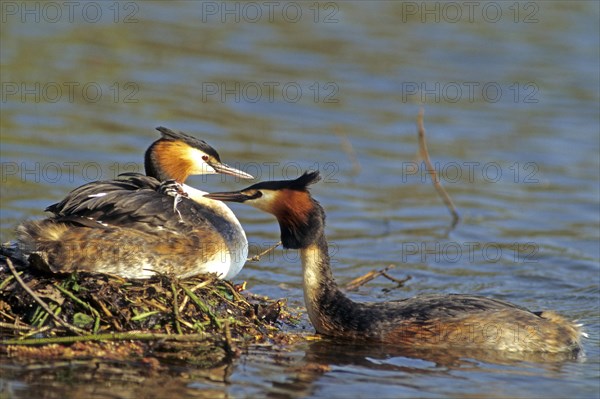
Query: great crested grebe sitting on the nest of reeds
[{"left": 17, "top": 127, "right": 253, "bottom": 279}]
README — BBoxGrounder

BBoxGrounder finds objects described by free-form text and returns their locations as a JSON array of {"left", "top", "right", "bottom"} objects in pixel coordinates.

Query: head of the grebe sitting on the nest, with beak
[{"left": 144, "top": 127, "right": 254, "bottom": 183}]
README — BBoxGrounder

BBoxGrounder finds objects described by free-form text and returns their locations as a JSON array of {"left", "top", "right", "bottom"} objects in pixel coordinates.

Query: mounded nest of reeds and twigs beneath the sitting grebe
[{"left": 0, "top": 257, "right": 298, "bottom": 367}]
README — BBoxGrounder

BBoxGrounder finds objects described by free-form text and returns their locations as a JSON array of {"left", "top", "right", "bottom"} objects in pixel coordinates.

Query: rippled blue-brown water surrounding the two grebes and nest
[{"left": 0, "top": 1, "right": 600, "bottom": 398}]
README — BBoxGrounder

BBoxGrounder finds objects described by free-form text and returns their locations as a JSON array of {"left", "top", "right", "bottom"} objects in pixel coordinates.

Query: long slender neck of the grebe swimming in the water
[{"left": 300, "top": 232, "right": 362, "bottom": 336}]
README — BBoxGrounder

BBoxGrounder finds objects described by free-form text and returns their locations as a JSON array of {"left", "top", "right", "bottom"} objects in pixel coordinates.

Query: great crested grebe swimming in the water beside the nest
[{"left": 206, "top": 172, "right": 582, "bottom": 354}]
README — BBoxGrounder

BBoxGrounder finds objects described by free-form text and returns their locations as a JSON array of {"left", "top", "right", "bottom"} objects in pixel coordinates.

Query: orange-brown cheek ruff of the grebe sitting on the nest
[{"left": 153, "top": 140, "right": 194, "bottom": 183}]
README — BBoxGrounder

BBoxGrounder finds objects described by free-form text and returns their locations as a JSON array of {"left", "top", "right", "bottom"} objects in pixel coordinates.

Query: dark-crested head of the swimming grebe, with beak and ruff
[{"left": 205, "top": 171, "right": 325, "bottom": 249}]
